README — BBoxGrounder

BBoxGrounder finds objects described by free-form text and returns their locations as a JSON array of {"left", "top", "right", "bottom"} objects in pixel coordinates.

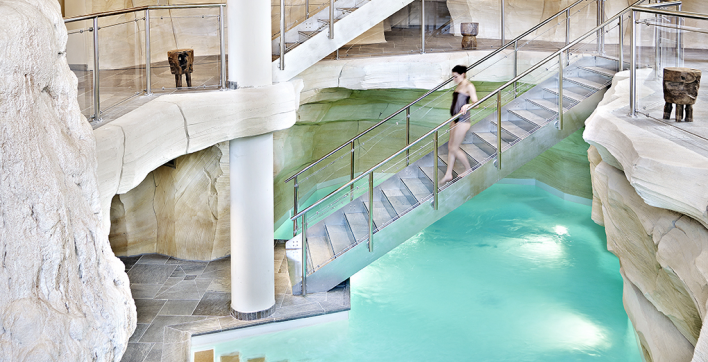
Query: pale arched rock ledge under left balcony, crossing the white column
[{"left": 94, "top": 81, "right": 302, "bottom": 243}]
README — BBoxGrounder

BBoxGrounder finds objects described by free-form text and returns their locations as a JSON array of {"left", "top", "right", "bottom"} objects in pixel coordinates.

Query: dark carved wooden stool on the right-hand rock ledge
[{"left": 664, "top": 67, "right": 701, "bottom": 122}]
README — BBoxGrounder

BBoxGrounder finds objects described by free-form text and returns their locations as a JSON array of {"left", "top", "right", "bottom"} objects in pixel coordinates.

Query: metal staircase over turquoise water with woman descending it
[{"left": 286, "top": 0, "right": 642, "bottom": 294}]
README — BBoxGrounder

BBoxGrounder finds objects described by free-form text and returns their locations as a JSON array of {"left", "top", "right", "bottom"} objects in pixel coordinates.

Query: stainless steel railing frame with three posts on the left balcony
[{"left": 64, "top": 4, "right": 227, "bottom": 120}]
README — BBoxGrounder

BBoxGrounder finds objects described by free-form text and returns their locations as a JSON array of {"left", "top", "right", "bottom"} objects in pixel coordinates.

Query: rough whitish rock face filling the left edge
[{"left": 0, "top": 0, "right": 136, "bottom": 361}]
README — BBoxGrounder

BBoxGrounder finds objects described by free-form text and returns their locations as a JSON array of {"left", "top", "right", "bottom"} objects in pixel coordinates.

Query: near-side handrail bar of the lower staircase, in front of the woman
[{"left": 290, "top": 0, "right": 656, "bottom": 220}]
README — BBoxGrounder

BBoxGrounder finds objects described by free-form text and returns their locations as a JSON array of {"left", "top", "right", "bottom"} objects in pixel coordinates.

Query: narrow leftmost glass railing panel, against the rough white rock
[{"left": 66, "top": 20, "right": 94, "bottom": 119}]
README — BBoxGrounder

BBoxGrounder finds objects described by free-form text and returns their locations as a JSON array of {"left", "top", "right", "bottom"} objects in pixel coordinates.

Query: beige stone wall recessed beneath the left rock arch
[{"left": 109, "top": 142, "right": 231, "bottom": 260}]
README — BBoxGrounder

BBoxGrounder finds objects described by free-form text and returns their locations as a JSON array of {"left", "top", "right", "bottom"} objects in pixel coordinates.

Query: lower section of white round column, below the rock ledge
[{"left": 229, "top": 133, "right": 275, "bottom": 320}]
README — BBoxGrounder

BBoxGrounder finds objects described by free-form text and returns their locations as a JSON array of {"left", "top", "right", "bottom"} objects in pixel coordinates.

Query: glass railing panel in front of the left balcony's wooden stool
[{"left": 150, "top": 8, "right": 221, "bottom": 93}]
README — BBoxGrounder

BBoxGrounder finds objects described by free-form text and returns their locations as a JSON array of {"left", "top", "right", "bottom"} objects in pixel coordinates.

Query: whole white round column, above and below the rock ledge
[{"left": 227, "top": 0, "right": 275, "bottom": 320}]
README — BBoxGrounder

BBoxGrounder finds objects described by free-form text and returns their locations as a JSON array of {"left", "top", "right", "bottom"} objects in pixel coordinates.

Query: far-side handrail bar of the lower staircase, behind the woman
[{"left": 283, "top": 0, "right": 588, "bottom": 183}]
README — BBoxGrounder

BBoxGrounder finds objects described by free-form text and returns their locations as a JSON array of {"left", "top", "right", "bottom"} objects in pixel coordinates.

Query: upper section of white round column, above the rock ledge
[{"left": 226, "top": 0, "right": 273, "bottom": 89}]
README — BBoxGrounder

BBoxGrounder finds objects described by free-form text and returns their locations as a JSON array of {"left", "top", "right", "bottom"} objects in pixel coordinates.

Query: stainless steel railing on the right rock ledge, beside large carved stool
[{"left": 629, "top": 5, "right": 696, "bottom": 117}]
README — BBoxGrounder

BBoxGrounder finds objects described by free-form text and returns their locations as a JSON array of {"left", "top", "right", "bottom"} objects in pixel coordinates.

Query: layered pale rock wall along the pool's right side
[{"left": 583, "top": 70, "right": 708, "bottom": 362}]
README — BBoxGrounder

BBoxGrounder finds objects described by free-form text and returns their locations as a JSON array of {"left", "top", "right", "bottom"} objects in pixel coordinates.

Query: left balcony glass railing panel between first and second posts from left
[{"left": 98, "top": 12, "right": 145, "bottom": 116}]
